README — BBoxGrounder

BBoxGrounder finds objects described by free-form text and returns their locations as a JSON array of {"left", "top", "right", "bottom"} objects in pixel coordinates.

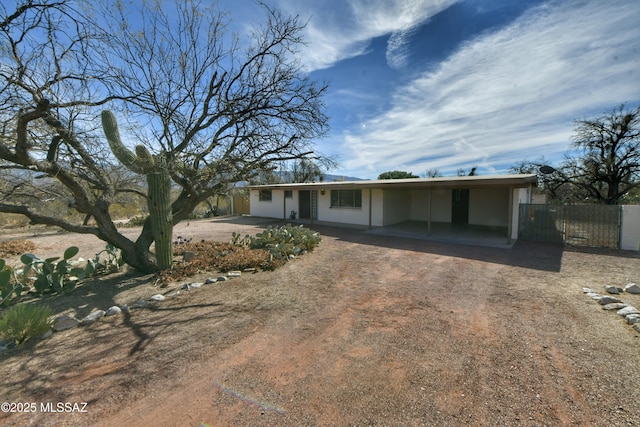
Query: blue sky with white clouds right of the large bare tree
[{"left": 221, "top": 0, "right": 640, "bottom": 179}]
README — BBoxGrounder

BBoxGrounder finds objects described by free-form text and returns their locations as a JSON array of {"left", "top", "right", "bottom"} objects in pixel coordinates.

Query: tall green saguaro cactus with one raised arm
[{"left": 102, "top": 110, "right": 173, "bottom": 270}]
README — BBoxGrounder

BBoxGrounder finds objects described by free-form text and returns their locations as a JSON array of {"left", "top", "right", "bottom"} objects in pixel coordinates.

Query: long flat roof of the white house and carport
[{"left": 249, "top": 174, "right": 538, "bottom": 190}]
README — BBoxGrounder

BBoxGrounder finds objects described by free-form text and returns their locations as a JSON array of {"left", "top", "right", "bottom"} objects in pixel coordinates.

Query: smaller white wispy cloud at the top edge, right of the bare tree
[{"left": 279, "top": 0, "right": 458, "bottom": 71}]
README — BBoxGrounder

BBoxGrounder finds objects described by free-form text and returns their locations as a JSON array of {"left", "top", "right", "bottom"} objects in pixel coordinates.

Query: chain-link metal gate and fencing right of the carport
[{"left": 518, "top": 204, "right": 622, "bottom": 249}]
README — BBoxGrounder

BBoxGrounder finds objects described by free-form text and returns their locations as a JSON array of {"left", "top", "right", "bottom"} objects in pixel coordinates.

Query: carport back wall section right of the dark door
[{"left": 469, "top": 188, "right": 510, "bottom": 227}]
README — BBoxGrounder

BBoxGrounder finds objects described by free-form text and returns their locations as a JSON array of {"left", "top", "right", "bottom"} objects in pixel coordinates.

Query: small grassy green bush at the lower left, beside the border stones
[{"left": 0, "top": 304, "right": 53, "bottom": 344}]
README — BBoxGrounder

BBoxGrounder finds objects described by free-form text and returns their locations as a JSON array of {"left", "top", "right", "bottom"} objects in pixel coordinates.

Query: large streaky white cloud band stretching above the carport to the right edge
[{"left": 340, "top": 0, "right": 640, "bottom": 177}]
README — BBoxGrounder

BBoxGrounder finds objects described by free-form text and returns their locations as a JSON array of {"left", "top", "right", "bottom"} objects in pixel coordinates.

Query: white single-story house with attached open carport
[{"left": 249, "top": 174, "right": 537, "bottom": 247}]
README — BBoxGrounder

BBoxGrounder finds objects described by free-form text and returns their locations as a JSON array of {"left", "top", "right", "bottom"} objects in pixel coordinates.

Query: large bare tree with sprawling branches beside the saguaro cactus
[{"left": 0, "top": 0, "right": 327, "bottom": 271}]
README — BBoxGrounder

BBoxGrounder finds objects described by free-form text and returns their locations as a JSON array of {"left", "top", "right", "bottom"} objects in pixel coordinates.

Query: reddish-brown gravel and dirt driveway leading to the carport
[{"left": 0, "top": 218, "right": 640, "bottom": 426}]
